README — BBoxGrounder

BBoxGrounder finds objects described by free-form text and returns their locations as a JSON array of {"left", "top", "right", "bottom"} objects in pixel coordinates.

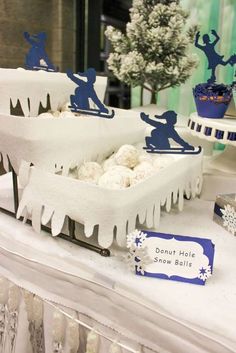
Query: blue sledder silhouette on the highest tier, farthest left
[{"left": 24, "top": 32, "right": 58, "bottom": 72}]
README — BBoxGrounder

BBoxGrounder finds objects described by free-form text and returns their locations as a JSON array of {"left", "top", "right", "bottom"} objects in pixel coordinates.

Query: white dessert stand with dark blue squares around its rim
[{"left": 188, "top": 113, "right": 236, "bottom": 175}]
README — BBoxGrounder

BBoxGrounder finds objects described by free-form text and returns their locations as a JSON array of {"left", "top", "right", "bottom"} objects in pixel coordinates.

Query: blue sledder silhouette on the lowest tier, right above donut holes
[{"left": 140, "top": 110, "right": 201, "bottom": 154}]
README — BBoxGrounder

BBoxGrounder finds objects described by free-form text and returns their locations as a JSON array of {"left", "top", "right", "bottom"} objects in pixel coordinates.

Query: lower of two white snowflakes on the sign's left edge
[{"left": 126, "top": 245, "right": 152, "bottom": 275}]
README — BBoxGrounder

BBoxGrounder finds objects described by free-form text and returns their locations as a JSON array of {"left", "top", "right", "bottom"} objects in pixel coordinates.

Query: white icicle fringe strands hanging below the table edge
[{"left": 0, "top": 278, "right": 141, "bottom": 353}]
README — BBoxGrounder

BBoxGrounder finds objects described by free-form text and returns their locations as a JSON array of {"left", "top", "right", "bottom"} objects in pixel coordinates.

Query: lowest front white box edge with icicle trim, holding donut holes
[{"left": 17, "top": 154, "right": 202, "bottom": 247}]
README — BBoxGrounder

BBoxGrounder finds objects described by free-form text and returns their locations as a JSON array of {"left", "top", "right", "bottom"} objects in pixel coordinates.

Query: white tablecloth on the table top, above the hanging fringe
[{"left": 0, "top": 194, "right": 236, "bottom": 353}]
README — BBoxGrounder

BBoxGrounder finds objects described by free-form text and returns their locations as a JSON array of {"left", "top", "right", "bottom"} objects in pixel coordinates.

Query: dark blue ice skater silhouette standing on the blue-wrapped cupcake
[{"left": 195, "top": 29, "right": 236, "bottom": 83}]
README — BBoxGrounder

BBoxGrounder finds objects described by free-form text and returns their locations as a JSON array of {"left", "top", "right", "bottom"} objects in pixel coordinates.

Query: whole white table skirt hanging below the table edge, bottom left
[{"left": 0, "top": 277, "right": 140, "bottom": 353}]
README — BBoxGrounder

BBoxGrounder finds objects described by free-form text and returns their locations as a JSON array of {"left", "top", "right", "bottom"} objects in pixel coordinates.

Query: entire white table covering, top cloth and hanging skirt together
[{"left": 0, "top": 200, "right": 236, "bottom": 353}]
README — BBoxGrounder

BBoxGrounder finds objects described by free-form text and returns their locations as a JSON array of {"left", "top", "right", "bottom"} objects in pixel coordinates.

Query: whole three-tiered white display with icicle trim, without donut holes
[{"left": 0, "top": 69, "right": 202, "bottom": 247}]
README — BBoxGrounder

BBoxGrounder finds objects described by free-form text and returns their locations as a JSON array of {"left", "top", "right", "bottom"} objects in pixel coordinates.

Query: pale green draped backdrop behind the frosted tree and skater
[{"left": 132, "top": 0, "right": 236, "bottom": 116}]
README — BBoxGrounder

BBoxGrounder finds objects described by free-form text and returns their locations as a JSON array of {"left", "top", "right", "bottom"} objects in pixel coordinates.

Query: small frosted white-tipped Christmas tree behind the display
[{"left": 105, "top": 0, "right": 198, "bottom": 103}]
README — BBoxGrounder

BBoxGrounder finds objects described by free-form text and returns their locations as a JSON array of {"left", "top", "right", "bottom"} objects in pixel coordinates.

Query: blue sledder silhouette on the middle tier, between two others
[{"left": 67, "top": 68, "right": 115, "bottom": 119}]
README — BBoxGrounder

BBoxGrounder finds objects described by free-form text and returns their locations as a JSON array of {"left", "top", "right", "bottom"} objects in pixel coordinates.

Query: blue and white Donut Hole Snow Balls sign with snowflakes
[{"left": 127, "top": 230, "right": 214, "bottom": 285}]
